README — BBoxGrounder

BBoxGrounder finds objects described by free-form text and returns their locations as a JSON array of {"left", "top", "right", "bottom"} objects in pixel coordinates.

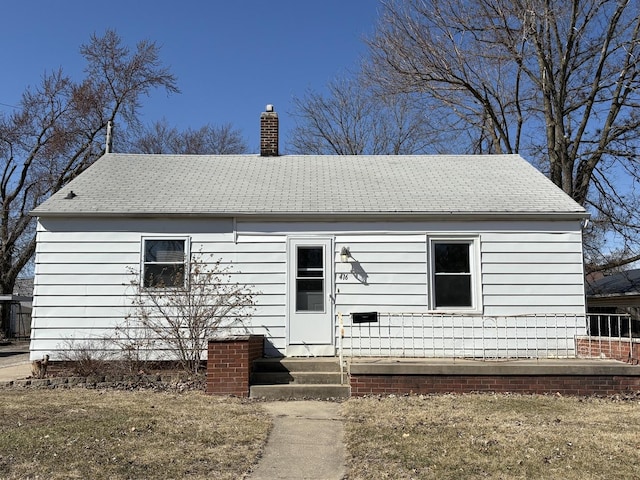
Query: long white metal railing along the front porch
[{"left": 339, "top": 313, "right": 633, "bottom": 360}]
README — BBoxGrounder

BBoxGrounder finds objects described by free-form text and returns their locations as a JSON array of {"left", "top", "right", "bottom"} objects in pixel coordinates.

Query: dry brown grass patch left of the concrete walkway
[{"left": 0, "top": 389, "right": 271, "bottom": 479}]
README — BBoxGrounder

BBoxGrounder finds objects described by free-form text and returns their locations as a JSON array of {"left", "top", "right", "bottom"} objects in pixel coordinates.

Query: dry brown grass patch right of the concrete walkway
[{"left": 344, "top": 395, "right": 640, "bottom": 480}]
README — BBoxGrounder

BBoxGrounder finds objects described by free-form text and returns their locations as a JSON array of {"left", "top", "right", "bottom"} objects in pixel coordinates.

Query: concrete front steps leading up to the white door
[{"left": 249, "top": 357, "right": 350, "bottom": 400}]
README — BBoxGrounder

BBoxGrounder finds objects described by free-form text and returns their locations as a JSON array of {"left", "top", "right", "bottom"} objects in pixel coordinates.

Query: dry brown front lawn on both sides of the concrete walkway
[{"left": 0, "top": 388, "right": 640, "bottom": 480}]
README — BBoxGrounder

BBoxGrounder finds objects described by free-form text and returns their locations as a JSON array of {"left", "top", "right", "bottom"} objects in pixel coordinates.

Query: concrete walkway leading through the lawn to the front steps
[{"left": 247, "top": 401, "right": 346, "bottom": 480}]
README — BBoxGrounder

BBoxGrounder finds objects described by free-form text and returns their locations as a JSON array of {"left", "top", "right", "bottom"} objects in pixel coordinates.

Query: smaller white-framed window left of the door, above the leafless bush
[{"left": 142, "top": 238, "right": 188, "bottom": 288}]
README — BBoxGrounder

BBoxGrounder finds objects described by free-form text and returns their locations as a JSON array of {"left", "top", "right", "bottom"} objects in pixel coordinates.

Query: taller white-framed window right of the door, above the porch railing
[{"left": 429, "top": 238, "right": 480, "bottom": 310}]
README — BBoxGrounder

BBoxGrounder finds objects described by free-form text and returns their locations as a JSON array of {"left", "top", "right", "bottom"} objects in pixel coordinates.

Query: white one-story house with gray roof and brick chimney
[{"left": 31, "top": 105, "right": 587, "bottom": 358}]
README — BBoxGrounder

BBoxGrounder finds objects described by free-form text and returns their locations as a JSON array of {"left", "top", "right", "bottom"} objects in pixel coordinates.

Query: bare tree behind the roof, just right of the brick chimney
[{"left": 289, "top": 77, "right": 435, "bottom": 155}]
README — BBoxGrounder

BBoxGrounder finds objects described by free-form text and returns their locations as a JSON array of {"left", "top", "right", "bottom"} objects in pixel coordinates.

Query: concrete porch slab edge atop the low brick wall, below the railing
[{"left": 347, "top": 357, "right": 640, "bottom": 377}]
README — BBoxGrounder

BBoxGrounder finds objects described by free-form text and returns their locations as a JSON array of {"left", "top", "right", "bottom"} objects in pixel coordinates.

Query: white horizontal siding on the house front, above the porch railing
[{"left": 32, "top": 218, "right": 584, "bottom": 359}]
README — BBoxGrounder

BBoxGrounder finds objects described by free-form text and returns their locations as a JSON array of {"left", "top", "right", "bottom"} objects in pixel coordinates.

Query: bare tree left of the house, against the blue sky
[{"left": 0, "top": 30, "right": 178, "bottom": 331}]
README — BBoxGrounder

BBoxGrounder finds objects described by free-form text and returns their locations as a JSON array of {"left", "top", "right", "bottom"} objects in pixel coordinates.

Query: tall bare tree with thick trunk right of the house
[{"left": 368, "top": 0, "right": 640, "bottom": 268}]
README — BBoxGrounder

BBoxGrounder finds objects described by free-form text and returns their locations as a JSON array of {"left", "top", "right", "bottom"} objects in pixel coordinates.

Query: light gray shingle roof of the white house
[{"left": 32, "top": 153, "right": 585, "bottom": 216}]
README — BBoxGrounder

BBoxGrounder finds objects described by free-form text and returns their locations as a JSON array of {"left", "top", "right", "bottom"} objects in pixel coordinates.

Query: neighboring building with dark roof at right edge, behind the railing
[{"left": 586, "top": 269, "right": 640, "bottom": 337}]
